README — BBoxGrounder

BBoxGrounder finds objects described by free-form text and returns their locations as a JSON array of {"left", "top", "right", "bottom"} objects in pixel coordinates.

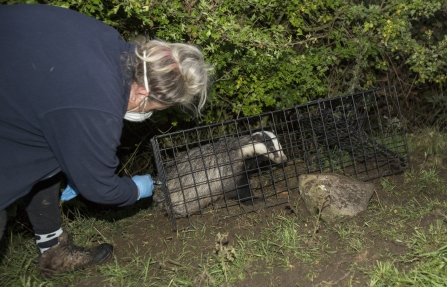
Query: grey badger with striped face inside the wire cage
[{"left": 154, "top": 131, "right": 287, "bottom": 216}]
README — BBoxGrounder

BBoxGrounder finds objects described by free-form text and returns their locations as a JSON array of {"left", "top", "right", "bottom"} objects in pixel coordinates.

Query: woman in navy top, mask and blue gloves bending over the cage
[{"left": 0, "top": 2, "right": 213, "bottom": 275}]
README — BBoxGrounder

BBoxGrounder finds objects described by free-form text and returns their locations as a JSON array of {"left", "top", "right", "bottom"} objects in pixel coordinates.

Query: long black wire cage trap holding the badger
[{"left": 151, "top": 86, "right": 410, "bottom": 230}]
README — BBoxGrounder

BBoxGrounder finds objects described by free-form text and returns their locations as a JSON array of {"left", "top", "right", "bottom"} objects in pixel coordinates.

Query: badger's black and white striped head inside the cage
[{"left": 242, "top": 131, "right": 287, "bottom": 163}]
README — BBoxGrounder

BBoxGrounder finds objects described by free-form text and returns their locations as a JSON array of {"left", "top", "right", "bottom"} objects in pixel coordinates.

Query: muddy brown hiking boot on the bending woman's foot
[{"left": 38, "top": 232, "right": 113, "bottom": 277}]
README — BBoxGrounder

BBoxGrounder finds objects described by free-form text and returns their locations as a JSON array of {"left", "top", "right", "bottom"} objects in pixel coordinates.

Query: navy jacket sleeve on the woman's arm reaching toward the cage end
[{"left": 41, "top": 108, "right": 138, "bottom": 206}]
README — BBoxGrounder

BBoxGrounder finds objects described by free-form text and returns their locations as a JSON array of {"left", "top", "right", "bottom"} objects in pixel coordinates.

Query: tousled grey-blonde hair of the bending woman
[{"left": 133, "top": 40, "right": 212, "bottom": 115}]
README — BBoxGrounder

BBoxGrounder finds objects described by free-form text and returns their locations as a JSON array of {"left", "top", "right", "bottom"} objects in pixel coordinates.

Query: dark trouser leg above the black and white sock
[{"left": 0, "top": 173, "right": 61, "bottom": 243}]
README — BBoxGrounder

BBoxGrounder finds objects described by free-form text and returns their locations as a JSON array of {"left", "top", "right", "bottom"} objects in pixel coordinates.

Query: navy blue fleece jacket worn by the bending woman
[{"left": 0, "top": 5, "right": 138, "bottom": 211}]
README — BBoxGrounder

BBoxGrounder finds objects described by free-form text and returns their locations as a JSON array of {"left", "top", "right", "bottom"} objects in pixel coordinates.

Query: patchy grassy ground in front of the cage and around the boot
[{"left": 0, "top": 130, "right": 447, "bottom": 287}]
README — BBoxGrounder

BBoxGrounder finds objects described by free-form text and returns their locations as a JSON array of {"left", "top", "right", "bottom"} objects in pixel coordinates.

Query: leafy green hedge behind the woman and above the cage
[{"left": 4, "top": 0, "right": 447, "bottom": 124}]
